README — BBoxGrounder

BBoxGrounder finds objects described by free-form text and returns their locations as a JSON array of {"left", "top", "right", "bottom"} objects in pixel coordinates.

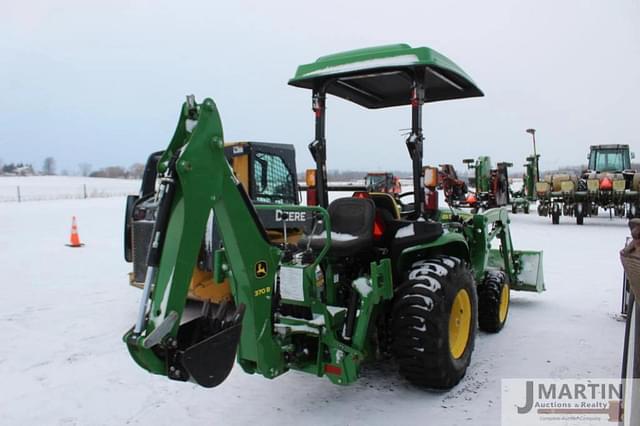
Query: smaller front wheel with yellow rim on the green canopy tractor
[{"left": 478, "top": 271, "right": 511, "bottom": 333}]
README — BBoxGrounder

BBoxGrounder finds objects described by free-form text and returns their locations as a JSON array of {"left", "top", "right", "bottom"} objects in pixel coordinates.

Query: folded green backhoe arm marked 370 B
[{"left": 124, "top": 98, "right": 284, "bottom": 386}]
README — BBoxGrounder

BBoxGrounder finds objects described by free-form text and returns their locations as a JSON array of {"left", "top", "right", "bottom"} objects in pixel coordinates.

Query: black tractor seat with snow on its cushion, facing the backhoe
[{"left": 298, "top": 197, "right": 376, "bottom": 257}]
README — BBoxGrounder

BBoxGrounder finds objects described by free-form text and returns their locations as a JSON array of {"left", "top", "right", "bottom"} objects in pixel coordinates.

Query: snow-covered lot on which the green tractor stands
[{"left": 0, "top": 187, "right": 628, "bottom": 426}]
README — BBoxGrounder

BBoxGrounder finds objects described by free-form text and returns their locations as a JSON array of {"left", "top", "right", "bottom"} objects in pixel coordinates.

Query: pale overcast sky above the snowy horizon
[{"left": 0, "top": 0, "right": 640, "bottom": 175}]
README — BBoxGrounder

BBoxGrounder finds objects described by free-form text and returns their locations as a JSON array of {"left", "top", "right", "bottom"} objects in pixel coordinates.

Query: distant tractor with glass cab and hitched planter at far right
[{"left": 536, "top": 145, "right": 640, "bottom": 225}]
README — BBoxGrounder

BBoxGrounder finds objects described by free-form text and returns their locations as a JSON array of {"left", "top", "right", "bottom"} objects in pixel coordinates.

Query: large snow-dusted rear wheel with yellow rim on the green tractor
[{"left": 391, "top": 256, "right": 478, "bottom": 389}]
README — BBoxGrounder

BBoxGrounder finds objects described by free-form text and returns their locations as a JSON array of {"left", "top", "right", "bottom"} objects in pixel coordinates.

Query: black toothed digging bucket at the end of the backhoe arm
[{"left": 169, "top": 305, "right": 244, "bottom": 388}]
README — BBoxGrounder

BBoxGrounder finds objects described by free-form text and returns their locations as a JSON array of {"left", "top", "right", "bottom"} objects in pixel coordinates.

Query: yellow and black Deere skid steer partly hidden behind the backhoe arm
[{"left": 124, "top": 142, "right": 305, "bottom": 303}]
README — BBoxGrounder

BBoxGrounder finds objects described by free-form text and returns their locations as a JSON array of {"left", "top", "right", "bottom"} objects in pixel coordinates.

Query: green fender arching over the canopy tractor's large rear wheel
[{"left": 397, "top": 231, "right": 470, "bottom": 271}]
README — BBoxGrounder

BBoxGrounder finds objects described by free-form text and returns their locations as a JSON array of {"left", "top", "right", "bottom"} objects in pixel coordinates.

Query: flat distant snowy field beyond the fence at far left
[{"left": 0, "top": 176, "right": 140, "bottom": 202}]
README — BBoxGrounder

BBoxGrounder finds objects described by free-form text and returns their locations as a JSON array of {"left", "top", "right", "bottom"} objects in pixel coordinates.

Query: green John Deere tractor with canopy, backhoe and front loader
[{"left": 124, "top": 44, "right": 544, "bottom": 389}]
